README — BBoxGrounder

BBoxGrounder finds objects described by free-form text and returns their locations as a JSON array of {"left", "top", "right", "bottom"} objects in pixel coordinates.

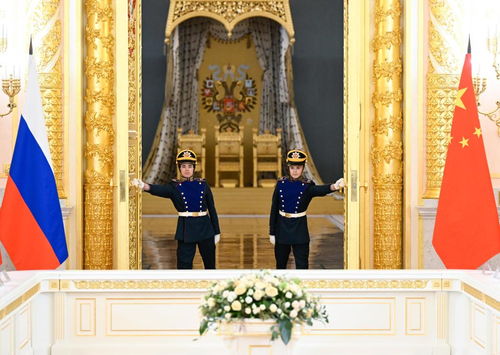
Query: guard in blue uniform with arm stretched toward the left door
[{"left": 133, "top": 149, "right": 220, "bottom": 269}]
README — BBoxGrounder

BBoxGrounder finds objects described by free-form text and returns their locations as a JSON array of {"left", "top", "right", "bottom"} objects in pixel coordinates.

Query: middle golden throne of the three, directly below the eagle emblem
[{"left": 215, "top": 125, "right": 244, "bottom": 187}]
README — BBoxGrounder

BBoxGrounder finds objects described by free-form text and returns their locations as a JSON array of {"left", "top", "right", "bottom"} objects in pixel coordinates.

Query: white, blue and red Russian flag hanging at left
[{"left": 0, "top": 55, "right": 68, "bottom": 270}]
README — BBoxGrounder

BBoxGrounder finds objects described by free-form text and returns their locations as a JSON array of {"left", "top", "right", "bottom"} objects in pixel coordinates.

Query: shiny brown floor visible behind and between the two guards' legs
[{"left": 142, "top": 214, "right": 344, "bottom": 269}]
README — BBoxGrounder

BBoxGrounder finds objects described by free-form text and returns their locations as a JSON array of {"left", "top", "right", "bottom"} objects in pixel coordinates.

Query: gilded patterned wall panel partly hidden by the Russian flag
[{"left": 31, "top": 0, "right": 66, "bottom": 198}]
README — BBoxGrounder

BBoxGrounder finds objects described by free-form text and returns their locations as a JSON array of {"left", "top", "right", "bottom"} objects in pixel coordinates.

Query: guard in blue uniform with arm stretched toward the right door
[{"left": 269, "top": 149, "right": 344, "bottom": 269}]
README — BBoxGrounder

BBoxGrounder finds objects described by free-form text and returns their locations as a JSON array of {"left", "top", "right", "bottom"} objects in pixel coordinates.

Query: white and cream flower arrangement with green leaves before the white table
[{"left": 199, "top": 271, "right": 328, "bottom": 344}]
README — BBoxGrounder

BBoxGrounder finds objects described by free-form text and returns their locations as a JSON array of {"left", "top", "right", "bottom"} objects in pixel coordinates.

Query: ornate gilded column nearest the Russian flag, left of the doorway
[{"left": 84, "top": 0, "right": 115, "bottom": 269}]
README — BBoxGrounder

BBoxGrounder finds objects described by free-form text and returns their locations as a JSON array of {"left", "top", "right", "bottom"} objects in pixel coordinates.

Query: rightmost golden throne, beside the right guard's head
[{"left": 253, "top": 128, "right": 281, "bottom": 187}]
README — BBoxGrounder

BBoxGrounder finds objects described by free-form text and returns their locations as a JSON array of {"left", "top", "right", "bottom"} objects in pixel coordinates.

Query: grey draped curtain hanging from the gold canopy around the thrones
[{"left": 144, "top": 18, "right": 321, "bottom": 184}]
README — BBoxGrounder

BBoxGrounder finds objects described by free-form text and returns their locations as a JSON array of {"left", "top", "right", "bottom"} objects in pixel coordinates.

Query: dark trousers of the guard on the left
[{"left": 177, "top": 238, "right": 215, "bottom": 269}]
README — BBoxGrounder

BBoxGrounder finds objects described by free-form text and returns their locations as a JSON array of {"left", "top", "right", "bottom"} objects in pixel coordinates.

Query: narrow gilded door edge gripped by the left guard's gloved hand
[{"left": 128, "top": 0, "right": 142, "bottom": 269}]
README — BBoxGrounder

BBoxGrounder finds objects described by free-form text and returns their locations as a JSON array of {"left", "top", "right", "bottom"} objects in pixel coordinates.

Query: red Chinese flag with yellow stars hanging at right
[{"left": 432, "top": 44, "right": 500, "bottom": 269}]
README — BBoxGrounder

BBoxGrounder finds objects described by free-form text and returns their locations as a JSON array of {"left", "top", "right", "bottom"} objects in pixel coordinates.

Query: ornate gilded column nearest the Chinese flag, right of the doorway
[{"left": 371, "top": 0, "right": 403, "bottom": 269}]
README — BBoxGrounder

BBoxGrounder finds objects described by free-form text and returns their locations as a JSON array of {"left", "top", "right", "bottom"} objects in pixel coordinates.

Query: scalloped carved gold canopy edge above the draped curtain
[{"left": 165, "top": 0, "right": 295, "bottom": 43}]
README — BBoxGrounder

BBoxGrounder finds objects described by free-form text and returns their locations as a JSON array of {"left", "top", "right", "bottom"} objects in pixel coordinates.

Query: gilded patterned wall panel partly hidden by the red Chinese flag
[{"left": 424, "top": 0, "right": 466, "bottom": 198}]
